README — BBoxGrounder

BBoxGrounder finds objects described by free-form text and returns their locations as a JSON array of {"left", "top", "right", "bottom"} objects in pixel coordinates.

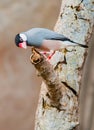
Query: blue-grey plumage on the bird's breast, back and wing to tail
[{"left": 23, "top": 28, "right": 87, "bottom": 48}]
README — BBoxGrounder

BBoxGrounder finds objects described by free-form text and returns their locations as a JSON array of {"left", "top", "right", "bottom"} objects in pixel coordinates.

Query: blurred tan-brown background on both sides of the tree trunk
[{"left": 0, "top": 0, "right": 94, "bottom": 130}]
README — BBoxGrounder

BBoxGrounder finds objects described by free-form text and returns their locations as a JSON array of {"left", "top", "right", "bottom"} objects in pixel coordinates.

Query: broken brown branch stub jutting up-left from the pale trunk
[{"left": 30, "top": 48, "right": 66, "bottom": 109}]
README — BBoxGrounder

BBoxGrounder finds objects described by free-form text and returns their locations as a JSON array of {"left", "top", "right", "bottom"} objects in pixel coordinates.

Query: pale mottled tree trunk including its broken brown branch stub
[{"left": 30, "top": 0, "right": 94, "bottom": 130}]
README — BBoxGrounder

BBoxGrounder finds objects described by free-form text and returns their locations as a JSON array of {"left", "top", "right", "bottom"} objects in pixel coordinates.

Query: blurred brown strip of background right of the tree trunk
[{"left": 80, "top": 33, "right": 94, "bottom": 130}]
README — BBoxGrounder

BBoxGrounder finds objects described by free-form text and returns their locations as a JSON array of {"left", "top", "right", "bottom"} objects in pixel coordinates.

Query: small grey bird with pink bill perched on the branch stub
[{"left": 15, "top": 28, "right": 88, "bottom": 58}]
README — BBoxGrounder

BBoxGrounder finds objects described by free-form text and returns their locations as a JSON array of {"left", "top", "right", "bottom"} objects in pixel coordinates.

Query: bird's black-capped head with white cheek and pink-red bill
[{"left": 15, "top": 33, "right": 27, "bottom": 49}]
